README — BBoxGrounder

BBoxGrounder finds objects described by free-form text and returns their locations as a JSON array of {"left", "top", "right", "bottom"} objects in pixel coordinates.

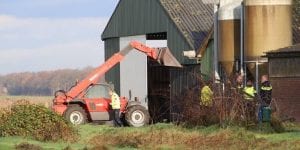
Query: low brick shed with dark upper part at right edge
[{"left": 267, "top": 44, "right": 300, "bottom": 121}]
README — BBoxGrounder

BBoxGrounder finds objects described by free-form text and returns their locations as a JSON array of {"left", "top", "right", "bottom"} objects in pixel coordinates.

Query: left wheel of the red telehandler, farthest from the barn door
[{"left": 64, "top": 105, "right": 87, "bottom": 125}]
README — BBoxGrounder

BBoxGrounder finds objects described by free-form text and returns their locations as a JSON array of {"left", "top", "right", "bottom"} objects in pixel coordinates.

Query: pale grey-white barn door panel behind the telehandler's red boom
[{"left": 120, "top": 35, "right": 148, "bottom": 108}]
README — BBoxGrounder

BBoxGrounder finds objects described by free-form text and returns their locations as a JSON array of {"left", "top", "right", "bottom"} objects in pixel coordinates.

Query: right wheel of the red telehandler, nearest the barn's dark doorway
[{"left": 125, "top": 105, "right": 150, "bottom": 127}]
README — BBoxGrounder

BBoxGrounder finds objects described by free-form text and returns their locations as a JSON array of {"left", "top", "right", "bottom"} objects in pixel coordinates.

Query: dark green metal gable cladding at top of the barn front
[{"left": 102, "top": 0, "right": 169, "bottom": 39}]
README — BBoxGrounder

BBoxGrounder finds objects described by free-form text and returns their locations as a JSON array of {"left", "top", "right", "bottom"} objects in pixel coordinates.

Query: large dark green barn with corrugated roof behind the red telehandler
[{"left": 102, "top": 0, "right": 213, "bottom": 120}]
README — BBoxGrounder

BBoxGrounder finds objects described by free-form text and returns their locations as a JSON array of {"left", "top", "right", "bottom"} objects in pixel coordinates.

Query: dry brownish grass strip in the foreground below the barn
[{"left": 89, "top": 124, "right": 300, "bottom": 149}]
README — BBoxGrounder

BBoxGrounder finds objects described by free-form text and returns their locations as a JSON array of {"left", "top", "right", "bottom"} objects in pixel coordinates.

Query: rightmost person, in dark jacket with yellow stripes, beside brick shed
[{"left": 260, "top": 75, "right": 272, "bottom": 106}]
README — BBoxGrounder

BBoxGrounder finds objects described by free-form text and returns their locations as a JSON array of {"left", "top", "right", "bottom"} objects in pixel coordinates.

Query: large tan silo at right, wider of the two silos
[{"left": 244, "top": 0, "right": 292, "bottom": 61}]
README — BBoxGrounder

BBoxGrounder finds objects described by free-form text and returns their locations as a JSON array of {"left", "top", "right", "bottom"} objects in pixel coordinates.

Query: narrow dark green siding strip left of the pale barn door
[{"left": 104, "top": 38, "right": 120, "bottom": 93}]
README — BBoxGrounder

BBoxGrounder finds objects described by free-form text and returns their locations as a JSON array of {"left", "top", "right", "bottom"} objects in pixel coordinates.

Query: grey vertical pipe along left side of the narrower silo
[{"left": 214, "top": 4, "right": 220, "bottom": 83}]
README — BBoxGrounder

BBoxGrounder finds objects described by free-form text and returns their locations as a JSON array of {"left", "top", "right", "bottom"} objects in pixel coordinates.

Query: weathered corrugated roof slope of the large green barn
[{"left": 160, "top": 0, "right": 214, "bottom": 49}]
